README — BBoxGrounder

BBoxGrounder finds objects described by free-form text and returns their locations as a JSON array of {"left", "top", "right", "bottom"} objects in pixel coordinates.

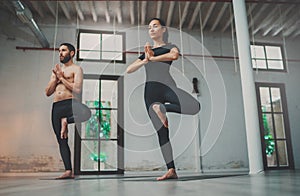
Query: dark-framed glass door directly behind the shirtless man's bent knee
[{"left": 74, "top": 75, "right": 124, "bottom": 174}]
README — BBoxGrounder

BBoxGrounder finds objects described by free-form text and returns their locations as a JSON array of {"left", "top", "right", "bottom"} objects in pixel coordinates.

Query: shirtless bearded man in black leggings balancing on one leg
[{"left": 45, "top": 43, "right": 91, "bottom": 179}]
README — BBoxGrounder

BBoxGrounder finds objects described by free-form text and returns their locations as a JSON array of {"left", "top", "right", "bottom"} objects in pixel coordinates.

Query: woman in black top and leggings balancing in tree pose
[{"left": 127, "top": 18, "right": 200, "bottom": 180}]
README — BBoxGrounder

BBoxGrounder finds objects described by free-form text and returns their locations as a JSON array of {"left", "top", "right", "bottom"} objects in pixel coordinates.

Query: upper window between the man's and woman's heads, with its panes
[{"left": 77, "top": 30, "right": 126, "bottom": 63}]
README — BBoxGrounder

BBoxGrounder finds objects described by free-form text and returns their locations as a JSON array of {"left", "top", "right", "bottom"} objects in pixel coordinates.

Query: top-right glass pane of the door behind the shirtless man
[{"left": 101, "top": 80, "right": 118, "bottom": 108}]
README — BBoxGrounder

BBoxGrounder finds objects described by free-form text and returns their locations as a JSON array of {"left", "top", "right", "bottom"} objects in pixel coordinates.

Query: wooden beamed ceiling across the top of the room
[{"left": 0, "top": 0, "right": 300, "bottom": 47}]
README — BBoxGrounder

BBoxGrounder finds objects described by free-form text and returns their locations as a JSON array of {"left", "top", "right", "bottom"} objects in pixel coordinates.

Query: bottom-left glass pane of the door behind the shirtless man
[{"left": 80, "top": 141, "right": 99, "bottom": 171}]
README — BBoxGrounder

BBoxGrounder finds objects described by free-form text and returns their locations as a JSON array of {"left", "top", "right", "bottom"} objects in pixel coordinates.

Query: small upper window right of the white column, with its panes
[{"left": 250, "top": 44, "right": 286, "bottom": 71}]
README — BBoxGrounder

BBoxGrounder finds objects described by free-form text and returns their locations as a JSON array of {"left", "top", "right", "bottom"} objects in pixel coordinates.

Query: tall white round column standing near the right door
[{"left": 232, "top": 0, "right": 263, "bottom": 174}]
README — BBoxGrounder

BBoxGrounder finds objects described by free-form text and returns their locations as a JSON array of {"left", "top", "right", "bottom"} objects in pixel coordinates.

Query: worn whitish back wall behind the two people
[{"left": 0, "top": 22, "right": 300, "bottom": 172}]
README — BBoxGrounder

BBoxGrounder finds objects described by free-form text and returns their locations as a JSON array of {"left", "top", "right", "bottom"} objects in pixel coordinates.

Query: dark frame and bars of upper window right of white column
[{"left": 250, "top": 42, "right": 287, "bottom": 72}]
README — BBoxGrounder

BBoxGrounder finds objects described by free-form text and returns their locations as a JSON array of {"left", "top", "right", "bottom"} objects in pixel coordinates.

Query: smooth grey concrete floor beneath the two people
[{"left": 0, "top": 170, "right": 300, "bottom": 196}]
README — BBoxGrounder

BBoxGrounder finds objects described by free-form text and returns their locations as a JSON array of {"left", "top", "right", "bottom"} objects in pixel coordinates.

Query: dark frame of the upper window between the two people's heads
[{"left": 76, "top": 29, "right": 126, "bottom": 64}]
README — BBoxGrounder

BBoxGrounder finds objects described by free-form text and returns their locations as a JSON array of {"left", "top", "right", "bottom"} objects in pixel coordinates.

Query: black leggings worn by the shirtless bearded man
[{"left": 51, "top": 99, "right": 91, "bottom": 170}]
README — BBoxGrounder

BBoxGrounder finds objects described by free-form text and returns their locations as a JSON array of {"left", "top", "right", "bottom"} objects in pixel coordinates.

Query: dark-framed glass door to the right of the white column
[{"left": 256, "top": 83, "right": 294, "bottom": 169}]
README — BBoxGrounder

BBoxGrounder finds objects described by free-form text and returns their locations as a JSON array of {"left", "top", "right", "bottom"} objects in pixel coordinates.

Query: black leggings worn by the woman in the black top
[{"left": 144, "top": 82, "right": 200, "bottom": 169}]
